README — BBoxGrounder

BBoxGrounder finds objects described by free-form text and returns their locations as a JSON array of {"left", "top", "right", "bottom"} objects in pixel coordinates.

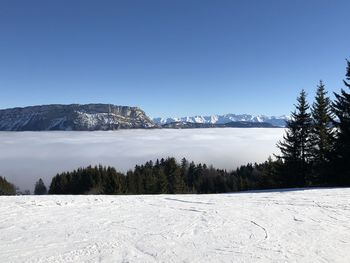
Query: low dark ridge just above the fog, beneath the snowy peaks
[{"left": 161, "top": 121, "right": 276, "bottom": 129}]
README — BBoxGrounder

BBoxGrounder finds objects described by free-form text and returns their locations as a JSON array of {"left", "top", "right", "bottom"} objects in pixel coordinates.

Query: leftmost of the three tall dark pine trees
[{"left": 277, "top": 90, "right": 312, "bottom": 186}]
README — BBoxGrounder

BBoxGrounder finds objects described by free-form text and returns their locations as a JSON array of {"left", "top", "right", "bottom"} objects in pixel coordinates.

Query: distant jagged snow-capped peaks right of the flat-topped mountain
[{"left": 153, "top": 114, "right": 288, "bottom": 127}]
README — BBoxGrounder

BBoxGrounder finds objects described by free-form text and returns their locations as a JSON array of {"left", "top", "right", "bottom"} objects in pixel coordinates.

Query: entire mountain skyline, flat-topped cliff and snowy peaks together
[{"left": 0, "top": 104, "right": 288, "bottom": 131}]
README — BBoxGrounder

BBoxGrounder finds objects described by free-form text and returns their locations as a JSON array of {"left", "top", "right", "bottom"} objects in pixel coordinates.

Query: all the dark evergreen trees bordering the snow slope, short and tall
[{"left": 0, "top": 61, "right": 350, "bottom": 194}]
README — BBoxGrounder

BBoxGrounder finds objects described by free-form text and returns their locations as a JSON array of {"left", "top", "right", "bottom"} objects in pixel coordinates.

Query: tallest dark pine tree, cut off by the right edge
[{"left": 333, "top": 61, "right": 350, "bottom": 185}]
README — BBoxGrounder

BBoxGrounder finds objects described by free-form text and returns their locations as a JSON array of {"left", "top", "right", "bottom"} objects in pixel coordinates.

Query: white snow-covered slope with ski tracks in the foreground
[{"left": 0, "top": 189, "right": 350, "bottom": 262}]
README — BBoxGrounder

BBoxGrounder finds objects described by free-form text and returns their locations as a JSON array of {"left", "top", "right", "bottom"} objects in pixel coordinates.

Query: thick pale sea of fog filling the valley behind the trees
[{"left": 0, "top": 128, "right": 284, "bottom": 190}]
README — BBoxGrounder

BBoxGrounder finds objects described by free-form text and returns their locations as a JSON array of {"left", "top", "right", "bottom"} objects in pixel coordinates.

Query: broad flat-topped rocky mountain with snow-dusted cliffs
[{"left": 0, "top": 104, "right": 157, "bottom": 131}]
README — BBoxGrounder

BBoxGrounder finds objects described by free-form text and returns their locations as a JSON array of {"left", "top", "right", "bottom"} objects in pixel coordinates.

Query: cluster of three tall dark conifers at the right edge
[{"left": 276, "top": 61, "right": 350, "bottom": 187}]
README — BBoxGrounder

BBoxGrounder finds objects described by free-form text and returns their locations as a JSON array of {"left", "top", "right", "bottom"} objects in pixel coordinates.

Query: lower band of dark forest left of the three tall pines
[{"left": 49, "top": 157, "right": 284, "bottom": 194}]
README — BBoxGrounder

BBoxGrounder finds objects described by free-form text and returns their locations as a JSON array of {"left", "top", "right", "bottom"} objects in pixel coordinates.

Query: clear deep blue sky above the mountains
[{"left": 0, "top": 0, "right": 350, "bottom": 117}]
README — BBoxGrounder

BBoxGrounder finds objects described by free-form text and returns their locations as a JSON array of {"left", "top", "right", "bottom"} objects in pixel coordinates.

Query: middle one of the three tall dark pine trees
[{"left": 309, "top": 81, "right": 334, "bottom": 185}]
